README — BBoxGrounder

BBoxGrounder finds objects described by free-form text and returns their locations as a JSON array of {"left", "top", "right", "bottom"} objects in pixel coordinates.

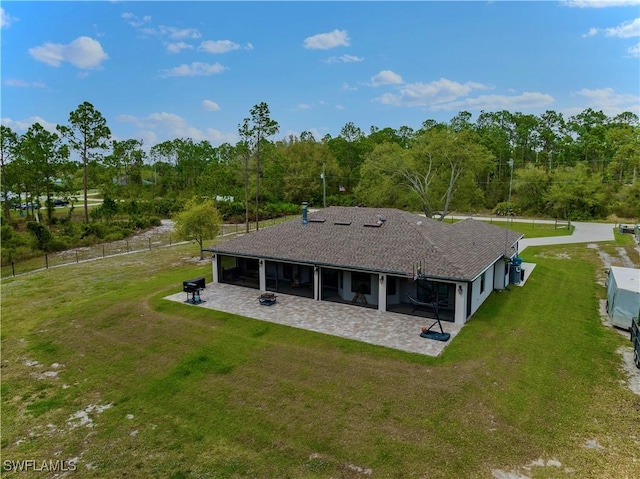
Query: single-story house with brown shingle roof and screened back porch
[{"left": 205, "top": 205, "right": 523, "bottom": 324}]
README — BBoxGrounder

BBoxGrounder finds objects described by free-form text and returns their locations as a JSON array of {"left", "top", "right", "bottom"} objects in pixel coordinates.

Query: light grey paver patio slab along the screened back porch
[{"left": 165, "top": 283, "right": 462, "bottom": 356}]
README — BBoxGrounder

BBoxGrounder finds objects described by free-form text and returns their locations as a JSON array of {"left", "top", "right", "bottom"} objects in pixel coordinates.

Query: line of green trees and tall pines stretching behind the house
[{"left": 0, "top": 102, "right": 640, "bottom": 229}]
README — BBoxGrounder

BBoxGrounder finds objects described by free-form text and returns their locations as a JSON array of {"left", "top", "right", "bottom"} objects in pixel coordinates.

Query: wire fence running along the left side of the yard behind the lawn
[{"left": 1, "top": 219, "right": 278, "bottom": 278}]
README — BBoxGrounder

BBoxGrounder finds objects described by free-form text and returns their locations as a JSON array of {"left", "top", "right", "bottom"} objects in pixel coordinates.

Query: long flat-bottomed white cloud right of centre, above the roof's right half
[{"left": 373, "top": 78, "right": 489, "bottom": 107}]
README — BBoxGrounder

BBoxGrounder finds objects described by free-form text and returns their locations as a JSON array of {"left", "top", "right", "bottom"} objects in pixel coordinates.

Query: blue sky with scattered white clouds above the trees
[{"left": 0, "top": 0, "right": 640, "bottom": 147}]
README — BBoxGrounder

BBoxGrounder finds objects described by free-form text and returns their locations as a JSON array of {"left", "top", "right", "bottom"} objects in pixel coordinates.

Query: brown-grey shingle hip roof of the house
[{"left": 205, "top": 206, "right": 523, "bottom": 281}]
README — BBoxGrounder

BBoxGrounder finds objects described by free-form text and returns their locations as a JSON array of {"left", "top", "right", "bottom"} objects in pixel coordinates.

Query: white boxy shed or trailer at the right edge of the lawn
[{"left": 607, "top": 266, "right": 640, "bottom": 329}]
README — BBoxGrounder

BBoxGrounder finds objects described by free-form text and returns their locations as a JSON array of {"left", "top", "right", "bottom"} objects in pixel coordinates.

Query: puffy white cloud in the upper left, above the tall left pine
[{"left": 29, "top": 37, "right": 109, "bottom": 69}]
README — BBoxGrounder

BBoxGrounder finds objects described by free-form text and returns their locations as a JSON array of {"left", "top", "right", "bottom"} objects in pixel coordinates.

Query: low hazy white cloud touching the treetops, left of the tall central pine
[{"left": 116, "top": 112, "right": 237, "bottom": 146}]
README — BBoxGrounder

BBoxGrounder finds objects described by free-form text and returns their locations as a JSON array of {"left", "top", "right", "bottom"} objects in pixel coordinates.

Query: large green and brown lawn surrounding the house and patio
[{"left": 1, "top": 245, "right": 640, "bottom": 479}]
